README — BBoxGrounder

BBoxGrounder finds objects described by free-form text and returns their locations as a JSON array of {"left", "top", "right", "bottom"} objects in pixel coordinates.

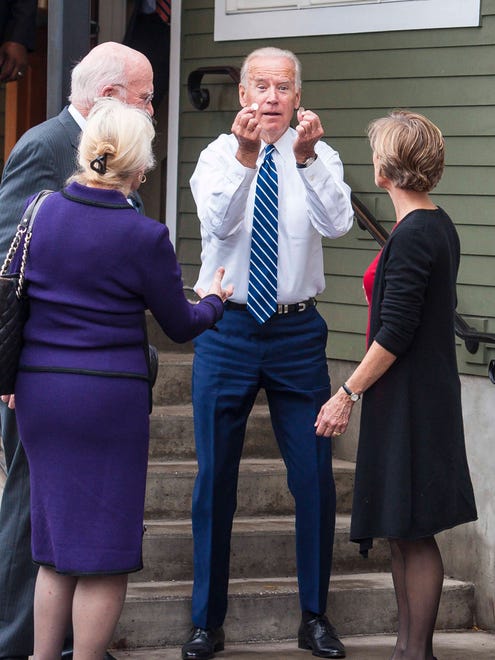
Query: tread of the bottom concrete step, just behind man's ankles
[{"left": 127, "top": 573, "right": 473, "bottom": 602}]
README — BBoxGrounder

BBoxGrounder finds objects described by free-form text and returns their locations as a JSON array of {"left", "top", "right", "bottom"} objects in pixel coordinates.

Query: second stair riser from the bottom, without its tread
[{"left": 131, "top": 530, "right": 389, "bottom": 582}]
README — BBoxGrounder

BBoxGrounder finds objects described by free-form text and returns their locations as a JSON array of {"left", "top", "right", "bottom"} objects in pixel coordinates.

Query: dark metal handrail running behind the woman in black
[{"left": 351, "top": 193, "right": 495, "bottom": 358}]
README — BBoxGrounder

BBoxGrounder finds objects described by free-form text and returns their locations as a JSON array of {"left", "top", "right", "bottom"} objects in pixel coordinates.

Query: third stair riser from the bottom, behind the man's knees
[{"left": 145, "top": 468, "right": 353, "bottom": 520}]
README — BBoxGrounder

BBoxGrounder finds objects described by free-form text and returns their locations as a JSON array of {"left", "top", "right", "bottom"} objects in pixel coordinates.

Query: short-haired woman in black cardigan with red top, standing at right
[{"left": 316, "top": 111, "right": 476, "bottom": 660}]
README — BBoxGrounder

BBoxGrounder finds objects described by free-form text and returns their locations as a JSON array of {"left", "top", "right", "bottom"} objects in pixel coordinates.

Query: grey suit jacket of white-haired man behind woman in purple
[{"left": 0, "top": 108, "right": 80, "bottom": 262}]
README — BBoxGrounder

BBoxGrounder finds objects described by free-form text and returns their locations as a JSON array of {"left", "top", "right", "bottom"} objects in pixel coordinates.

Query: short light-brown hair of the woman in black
[{"left": 368, "top": 110, "right": 445, "bottom": 192}]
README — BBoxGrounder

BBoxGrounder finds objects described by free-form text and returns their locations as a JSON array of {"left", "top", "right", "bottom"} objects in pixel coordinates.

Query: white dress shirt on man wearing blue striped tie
[{"left": 190, "top": 128, "right": 353, "bottom": 304}]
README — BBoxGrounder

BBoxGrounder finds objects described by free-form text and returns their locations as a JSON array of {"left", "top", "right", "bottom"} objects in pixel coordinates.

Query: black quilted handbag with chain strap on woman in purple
[{"left": 0, "top": 190, "right": 51, "bottom": 394}]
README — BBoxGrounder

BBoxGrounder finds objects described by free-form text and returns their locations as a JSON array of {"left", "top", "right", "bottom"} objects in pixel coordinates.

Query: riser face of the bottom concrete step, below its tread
[{"left": 114, "top": 586, "right": 474, "bottom": 648}]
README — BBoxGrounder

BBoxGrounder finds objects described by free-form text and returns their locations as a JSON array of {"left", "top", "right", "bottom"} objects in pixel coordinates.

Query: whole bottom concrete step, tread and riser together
[{"left": 113, "top": 573, "right": 474, "bottom": 657}]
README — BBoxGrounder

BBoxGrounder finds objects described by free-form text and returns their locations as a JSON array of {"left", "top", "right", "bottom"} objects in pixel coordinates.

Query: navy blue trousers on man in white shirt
[{"left": 192, "top": 307, "right": 335, "bottom": 628}]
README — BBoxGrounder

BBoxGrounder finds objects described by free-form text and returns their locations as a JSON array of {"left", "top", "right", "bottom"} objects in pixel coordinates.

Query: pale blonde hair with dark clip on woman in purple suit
[{"left": 71, "top": 97, "right": 155, "bottom": 190}]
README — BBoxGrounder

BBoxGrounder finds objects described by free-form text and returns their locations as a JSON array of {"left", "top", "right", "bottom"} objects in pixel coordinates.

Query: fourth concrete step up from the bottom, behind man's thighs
[{"left": 150, "top": 404, "right": 280, "bottom": 460}]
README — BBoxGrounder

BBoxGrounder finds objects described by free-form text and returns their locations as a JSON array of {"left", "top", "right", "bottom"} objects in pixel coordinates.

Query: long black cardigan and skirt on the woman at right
[{"left": 351, "top": 209, "right": 476, "bottom": 542}]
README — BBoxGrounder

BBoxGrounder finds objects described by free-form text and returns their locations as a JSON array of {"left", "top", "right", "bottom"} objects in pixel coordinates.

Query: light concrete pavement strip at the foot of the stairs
[{"left": 112, "top": 630, "right": 495, "bottom": 660}]
